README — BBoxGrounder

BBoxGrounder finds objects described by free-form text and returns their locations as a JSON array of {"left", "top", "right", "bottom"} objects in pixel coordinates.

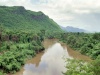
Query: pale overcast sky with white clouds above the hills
[{"left": 0, "top": 0, "right": 100, "bottom": 32}]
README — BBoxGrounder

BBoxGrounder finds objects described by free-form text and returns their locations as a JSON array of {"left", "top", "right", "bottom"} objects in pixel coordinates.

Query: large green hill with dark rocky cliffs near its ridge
[{"left": 0, "top": 6, "right": 62, "bottom": 33}]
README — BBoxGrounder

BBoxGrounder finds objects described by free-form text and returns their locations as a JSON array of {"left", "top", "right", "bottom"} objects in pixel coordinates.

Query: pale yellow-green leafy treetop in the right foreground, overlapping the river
[{"left": 63, "top": 59, "right": 94, "bottom": 75}]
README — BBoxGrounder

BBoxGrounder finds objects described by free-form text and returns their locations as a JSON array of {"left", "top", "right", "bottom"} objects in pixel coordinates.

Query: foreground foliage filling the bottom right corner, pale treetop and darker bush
[{"left": 63, "top": 56, "right": 100, "bottom": 75}]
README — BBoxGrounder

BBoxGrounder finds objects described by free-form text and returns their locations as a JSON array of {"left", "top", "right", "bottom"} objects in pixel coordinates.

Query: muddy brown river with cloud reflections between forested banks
[{"left": 14, "top": 39, "right": 91, "bottom": 75}]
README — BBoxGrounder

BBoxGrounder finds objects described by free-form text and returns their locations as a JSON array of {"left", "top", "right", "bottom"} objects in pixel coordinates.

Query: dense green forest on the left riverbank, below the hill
[{"left": 0, "top": 27, "right": 45, "bottom": 75}]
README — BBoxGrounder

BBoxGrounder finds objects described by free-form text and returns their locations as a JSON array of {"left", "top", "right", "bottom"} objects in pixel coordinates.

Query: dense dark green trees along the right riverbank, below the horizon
[{"left": 57, "top": 33, "right": 100, "bottom": 59}]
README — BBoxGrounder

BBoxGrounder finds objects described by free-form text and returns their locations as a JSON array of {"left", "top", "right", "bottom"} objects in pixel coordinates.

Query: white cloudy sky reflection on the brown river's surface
[{"left": 23, "top": 43, "right": 68, "bottom": 75}]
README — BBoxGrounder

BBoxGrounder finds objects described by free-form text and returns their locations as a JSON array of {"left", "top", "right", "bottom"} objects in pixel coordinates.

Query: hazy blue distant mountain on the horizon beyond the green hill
[{"left": 60, "top": 26, "right": 86, "bottom": 32}]
